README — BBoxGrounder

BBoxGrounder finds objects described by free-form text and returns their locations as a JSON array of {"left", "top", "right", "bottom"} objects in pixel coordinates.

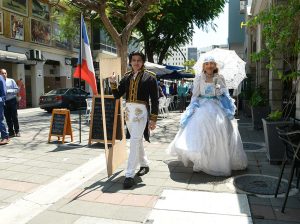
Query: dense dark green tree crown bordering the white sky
[{"left": 137, "top": 0, "right": 227, "bottom": 64}]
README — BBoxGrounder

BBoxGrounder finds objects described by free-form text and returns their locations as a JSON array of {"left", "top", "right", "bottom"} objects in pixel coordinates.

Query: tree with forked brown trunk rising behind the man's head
[{"left": 64, "top": 0, "right": 163, "bottom": 74}]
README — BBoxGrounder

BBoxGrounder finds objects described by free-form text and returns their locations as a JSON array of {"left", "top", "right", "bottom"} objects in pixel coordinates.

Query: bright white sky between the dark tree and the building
[{"left": 189, "top": 3, "right": 228, "bottom": 48}]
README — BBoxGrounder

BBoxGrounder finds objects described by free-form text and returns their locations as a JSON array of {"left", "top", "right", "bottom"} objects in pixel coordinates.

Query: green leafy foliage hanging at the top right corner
[{"left": 247, "top": 0, "right": 300, "bottom": 80}]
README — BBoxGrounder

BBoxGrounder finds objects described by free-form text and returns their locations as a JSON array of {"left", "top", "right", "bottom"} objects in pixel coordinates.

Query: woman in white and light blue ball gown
[{"left": 168, "top": 57, "right": 247, "bottom": 176}]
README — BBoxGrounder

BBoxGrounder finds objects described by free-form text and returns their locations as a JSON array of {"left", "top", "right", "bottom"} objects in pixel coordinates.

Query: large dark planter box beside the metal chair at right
[{"left": 262, "top": 119, "right": 293, "bottom": 164}]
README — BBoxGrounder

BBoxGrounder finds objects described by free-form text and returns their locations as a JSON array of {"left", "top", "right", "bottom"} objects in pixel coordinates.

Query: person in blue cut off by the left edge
[{"left": 0, "top": 70, "right": 9, "bottom": 145}]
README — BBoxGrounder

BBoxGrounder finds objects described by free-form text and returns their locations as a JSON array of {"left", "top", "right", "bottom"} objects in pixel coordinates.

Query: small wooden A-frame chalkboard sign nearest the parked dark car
[{"left": 48, "top": 109, "right": 73, "bottom": 144}]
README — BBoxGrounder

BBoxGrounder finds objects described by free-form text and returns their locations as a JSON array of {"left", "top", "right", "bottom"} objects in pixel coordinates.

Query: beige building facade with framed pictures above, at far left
[{"left": 0, "top": 0, "right": 79, "bottom": 107}]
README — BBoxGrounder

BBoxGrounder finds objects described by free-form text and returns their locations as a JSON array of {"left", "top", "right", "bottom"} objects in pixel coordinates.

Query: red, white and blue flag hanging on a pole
[{"left": 73, "top": 16, "right": 98, "bottom": 95}]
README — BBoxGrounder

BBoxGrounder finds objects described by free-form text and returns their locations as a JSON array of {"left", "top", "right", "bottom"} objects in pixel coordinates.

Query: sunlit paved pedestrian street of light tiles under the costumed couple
[{"left": 0, "top": 108, "right": 300, "bottom": 224}]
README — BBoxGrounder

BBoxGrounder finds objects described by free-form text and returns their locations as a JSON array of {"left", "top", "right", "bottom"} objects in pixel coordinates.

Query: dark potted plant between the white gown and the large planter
[{"left": 249, "top": 87, "right": 270, "bottom": 130}]
